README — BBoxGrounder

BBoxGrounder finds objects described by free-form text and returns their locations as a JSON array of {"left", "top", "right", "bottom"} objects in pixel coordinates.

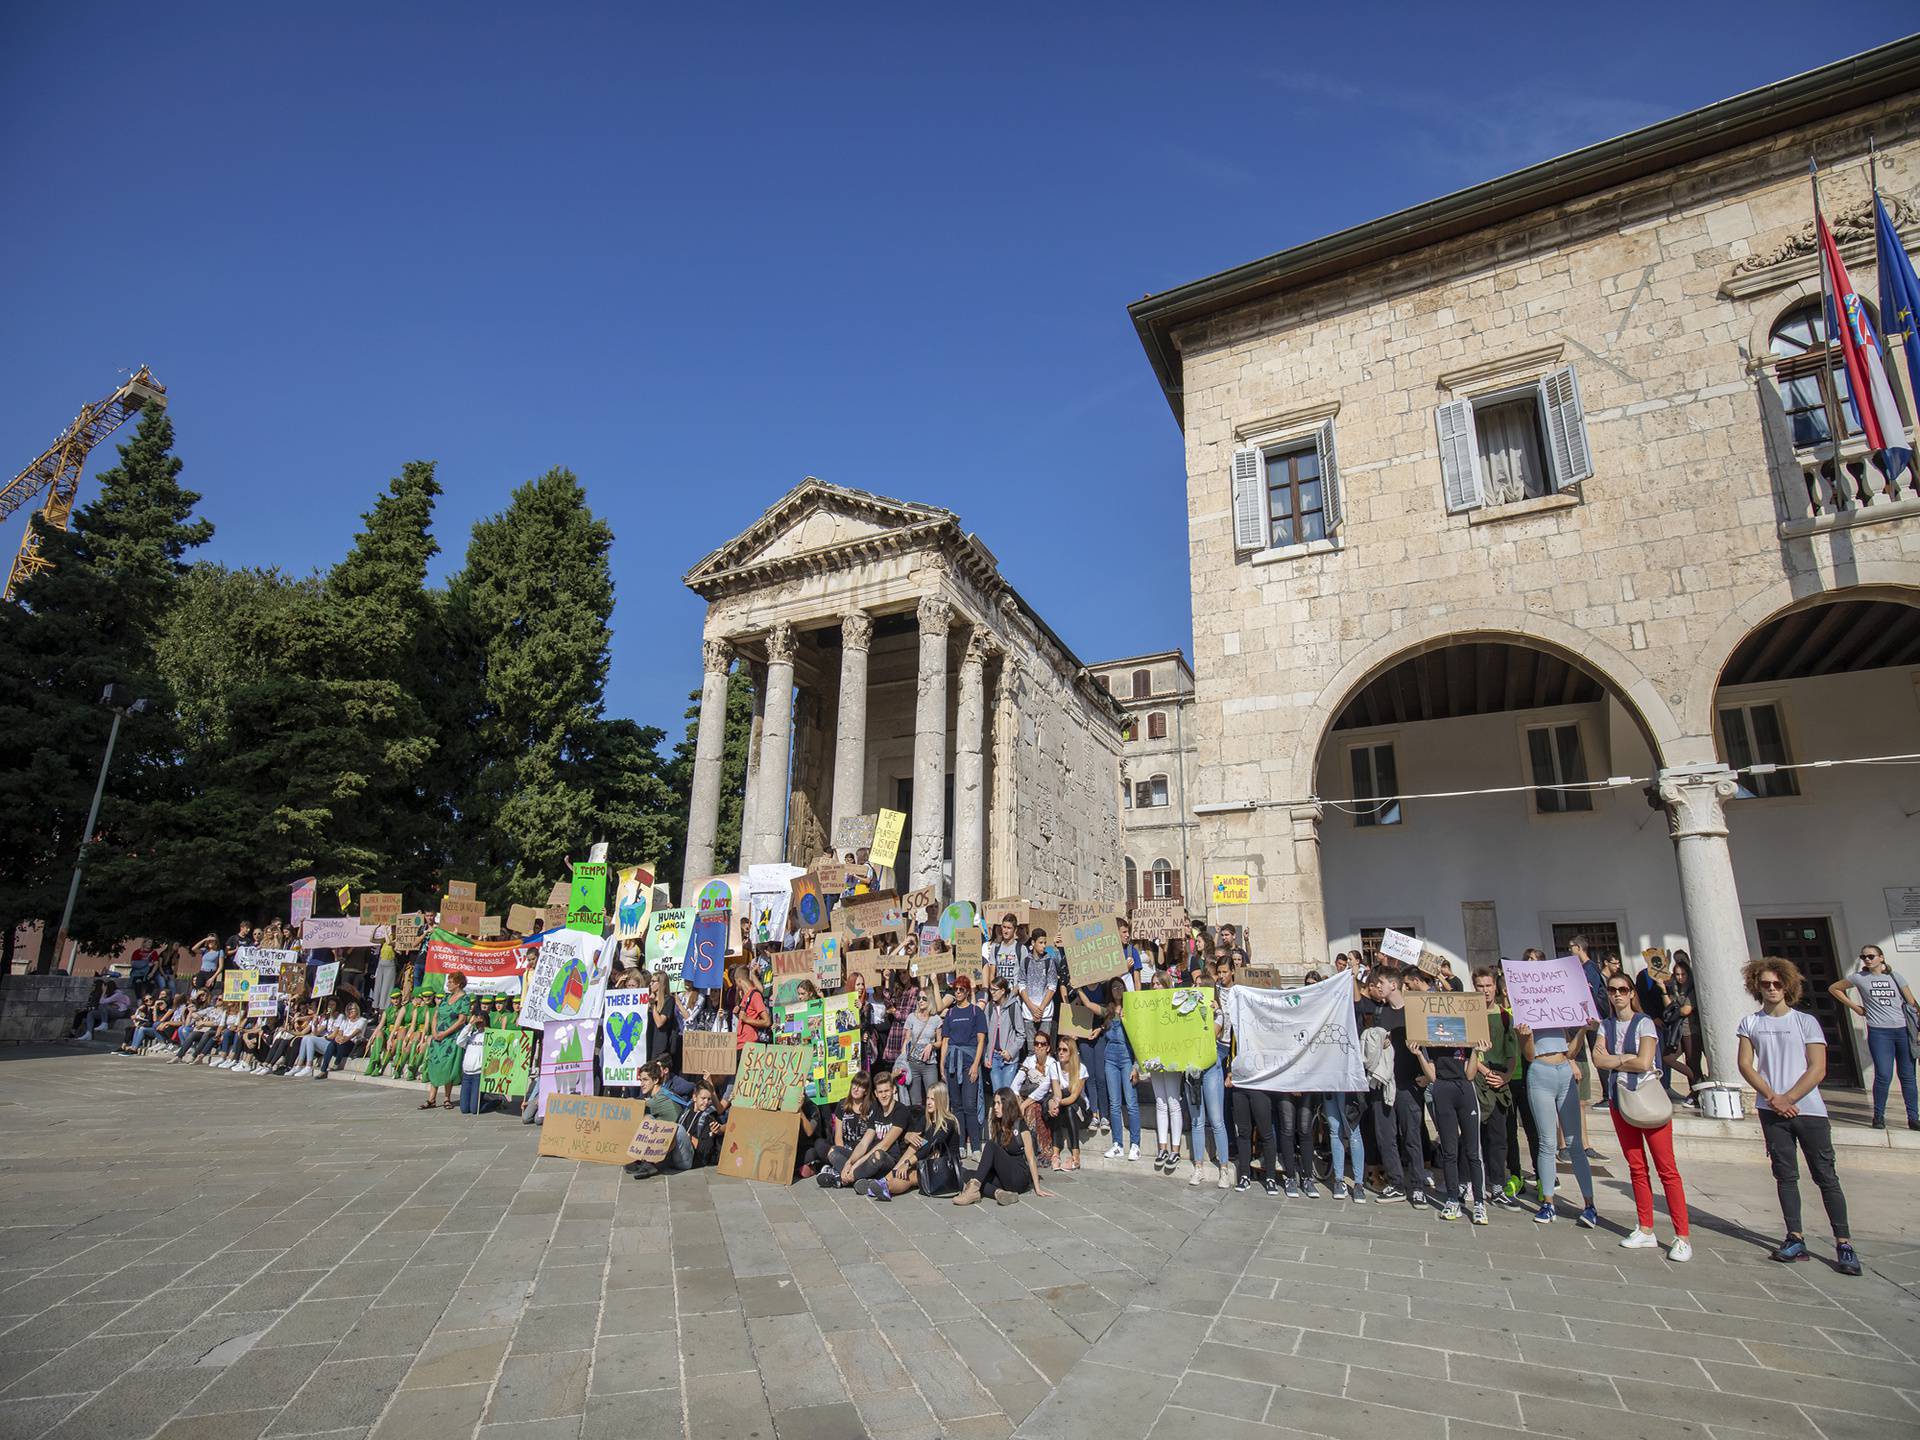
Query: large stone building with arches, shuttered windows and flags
[{"left": 1133, "top": 40, "right": 1920, "bottom": 1079}]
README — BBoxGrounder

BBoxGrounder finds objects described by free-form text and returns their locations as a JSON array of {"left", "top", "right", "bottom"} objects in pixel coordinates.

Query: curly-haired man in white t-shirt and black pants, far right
[{"left": 1740, "top": 956, "right": 1860, "bottom": 1275}]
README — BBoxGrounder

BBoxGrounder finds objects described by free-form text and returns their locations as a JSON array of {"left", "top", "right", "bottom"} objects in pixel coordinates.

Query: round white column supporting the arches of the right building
[{"left": 1655, "top": 764, "right": 1753, "bottom": 1089}]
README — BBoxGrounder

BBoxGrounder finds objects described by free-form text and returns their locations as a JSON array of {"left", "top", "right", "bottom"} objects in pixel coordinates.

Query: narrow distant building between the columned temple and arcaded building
[{"left": 1087, "top": 651, "right": 1206, "bottom": 906}]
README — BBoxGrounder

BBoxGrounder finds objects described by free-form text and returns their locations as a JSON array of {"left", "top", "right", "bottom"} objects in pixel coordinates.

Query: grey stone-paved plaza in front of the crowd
[{"left": 0, "top": 1050, "right": 1920, "bottom": 1440}]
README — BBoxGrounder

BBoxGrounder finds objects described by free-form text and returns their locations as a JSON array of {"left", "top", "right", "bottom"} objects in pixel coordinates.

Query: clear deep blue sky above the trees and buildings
[{"left": 0, "top": 0, "right": 1914, "bottom": 735}]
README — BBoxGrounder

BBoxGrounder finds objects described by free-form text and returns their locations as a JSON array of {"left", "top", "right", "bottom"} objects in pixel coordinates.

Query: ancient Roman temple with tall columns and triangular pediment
[{"left": 685, "top": 487, "right": 1121, "bottom": 902}]
